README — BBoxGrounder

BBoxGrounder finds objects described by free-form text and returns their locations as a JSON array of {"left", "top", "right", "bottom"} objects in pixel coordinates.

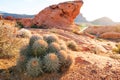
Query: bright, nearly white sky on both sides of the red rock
[{"left": 0, "top": 0, "right": 120, "bottom": 22}]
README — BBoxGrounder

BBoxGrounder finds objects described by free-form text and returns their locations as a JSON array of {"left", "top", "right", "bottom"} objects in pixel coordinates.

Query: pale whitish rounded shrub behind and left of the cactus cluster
[{"left": 17, "top": 28, "right": 31, "bottom": 38}]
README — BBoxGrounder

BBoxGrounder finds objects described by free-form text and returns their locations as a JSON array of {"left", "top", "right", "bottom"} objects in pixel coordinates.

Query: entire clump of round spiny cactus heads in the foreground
[{"left": 17, "top": 35, "right": 72, "bottom": 77}]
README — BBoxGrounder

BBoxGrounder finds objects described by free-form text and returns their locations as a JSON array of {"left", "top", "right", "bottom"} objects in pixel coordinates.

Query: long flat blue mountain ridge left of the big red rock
[{"left": 0, "top": 11, "right": 34, "bottom": 18}]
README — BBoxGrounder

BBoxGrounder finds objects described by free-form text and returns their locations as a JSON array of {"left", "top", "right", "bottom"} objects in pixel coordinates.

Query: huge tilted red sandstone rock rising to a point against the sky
[{"left": 33, "top": 0, "right": 83, "bottom": 30}]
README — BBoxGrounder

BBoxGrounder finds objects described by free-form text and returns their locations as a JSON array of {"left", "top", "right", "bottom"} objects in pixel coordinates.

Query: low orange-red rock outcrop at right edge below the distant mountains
[{"left": 84, "top": 26, "right": 120, "bottom": 39}]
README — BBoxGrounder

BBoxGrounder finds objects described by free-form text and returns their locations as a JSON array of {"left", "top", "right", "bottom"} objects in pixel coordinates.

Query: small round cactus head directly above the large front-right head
[{"left": 48, "top": 42, "right": 61, "bottom": 53}]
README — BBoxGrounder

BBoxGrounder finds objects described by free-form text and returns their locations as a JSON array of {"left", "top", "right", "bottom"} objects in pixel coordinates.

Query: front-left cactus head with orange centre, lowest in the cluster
[{"left": 26, "top": 58, "right": 43, "bottom": 77}]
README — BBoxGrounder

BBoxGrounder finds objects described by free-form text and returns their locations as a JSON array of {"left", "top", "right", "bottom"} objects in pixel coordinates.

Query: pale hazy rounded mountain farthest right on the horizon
[{"left": 91, "top": 17, "right": 116, "bottom": 25}]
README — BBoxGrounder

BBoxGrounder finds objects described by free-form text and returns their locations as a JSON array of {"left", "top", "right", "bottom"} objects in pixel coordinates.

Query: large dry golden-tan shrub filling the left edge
[{"left": 0, "top": 24, "right": 20, "bottom": 58}]
